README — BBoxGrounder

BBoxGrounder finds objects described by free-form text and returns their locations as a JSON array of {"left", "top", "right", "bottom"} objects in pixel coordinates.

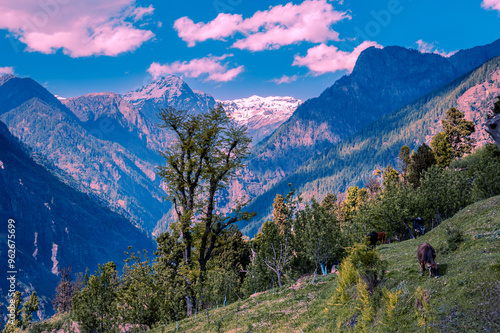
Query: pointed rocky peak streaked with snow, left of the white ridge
[{"left": 123, "top": 75, "right": 215, "bottom": 122}]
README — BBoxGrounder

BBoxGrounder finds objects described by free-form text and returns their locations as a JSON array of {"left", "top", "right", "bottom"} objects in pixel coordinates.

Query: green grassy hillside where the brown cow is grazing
[{"left": 153, "top": 196, "right": 500, "bottom": 332}]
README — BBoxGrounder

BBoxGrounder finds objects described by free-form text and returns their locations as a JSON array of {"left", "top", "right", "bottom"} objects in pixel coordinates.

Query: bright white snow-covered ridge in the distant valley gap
[{"left": 216, "top": 95, "right": 302, "bottom": 145}]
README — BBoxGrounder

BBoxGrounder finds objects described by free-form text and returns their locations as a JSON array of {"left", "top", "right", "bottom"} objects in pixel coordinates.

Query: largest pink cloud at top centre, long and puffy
[{"left": 174, "top": 0, "right": 350, "bottom": 51}]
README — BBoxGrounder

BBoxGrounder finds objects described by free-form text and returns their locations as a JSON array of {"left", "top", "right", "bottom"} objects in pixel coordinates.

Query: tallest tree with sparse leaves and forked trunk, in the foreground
[{"left": 158, "top": 106, "right": 251, "bottom": 316}]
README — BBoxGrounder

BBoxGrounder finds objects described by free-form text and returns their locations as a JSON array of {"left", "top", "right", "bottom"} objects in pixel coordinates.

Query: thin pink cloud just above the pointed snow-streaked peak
[{"left": 148, "top": 54, "right": 244, "bottom": 82}]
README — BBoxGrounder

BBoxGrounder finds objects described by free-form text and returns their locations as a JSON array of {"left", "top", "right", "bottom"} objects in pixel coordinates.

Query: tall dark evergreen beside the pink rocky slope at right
[{"left": 441, "top": 108, "right": 475, "bottom": 158}]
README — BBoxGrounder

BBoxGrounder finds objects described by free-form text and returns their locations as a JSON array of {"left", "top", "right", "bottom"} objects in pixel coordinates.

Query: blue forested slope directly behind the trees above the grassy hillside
[{"left": 239, "top": 57, "right": 500, "bottom": 237}]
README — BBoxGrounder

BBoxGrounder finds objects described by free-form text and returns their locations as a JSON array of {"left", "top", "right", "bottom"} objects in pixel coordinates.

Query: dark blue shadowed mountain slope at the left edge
[{"left": 0, "top": 122, "right": 154, "bottom": 313}]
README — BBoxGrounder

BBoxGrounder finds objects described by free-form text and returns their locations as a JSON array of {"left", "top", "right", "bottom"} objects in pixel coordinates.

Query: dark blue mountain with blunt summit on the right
[{"left": 249, "top": 40, "right": 500, "bottom": 183}]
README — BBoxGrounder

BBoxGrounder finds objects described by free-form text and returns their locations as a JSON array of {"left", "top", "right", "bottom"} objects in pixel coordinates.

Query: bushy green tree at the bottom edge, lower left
[{"left": 72, "top": 262, "right": 118, "bottom": 333}]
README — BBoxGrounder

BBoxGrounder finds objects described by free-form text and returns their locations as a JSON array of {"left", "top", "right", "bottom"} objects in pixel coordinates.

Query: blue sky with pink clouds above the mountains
[{"left": 0, "top": 0, "right": 500, "bottom": 99}]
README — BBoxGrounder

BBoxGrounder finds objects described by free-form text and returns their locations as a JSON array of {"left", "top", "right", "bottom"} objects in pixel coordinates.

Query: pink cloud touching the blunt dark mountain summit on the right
[{"left": 293, "top": 41, "right": 382, "bottom": 75}]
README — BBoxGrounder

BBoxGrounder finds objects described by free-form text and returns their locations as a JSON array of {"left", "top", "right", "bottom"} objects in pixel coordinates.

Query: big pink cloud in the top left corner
[{"left": 0, "top": 0, "right": 154, "bottom": 57}]
